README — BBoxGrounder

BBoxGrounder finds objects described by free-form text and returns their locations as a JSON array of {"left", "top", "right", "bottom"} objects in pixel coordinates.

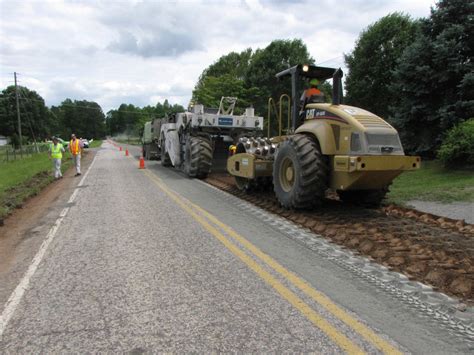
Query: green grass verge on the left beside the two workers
[{"left": 0, "top": 153, "right": 72, "bottom": 220}]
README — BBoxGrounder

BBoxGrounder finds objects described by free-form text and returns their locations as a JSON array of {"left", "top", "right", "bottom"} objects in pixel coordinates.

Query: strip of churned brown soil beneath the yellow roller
[{"left": 205, "top": 174, "right": 474, "bottom": 304}]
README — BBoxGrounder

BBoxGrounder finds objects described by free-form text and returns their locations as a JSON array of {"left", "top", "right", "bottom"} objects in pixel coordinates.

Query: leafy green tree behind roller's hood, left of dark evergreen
[{"left": 344, "top": 13, "right": 418, "bottom": 118}]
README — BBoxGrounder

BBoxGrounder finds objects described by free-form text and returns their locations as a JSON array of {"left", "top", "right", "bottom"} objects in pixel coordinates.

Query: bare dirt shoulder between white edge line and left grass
[{"left": 0, "top": 149, "right": 97, "bottom": 303}]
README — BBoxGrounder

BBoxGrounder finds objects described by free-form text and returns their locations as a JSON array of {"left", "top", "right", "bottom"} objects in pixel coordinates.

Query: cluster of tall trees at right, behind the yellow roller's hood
[{"left": 345, "top": 0, "right": 474, "bottom": 157}]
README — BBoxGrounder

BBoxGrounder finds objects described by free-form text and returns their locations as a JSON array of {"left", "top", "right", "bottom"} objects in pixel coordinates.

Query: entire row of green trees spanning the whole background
[{"left": 0, "top": 0, "right": 474, "bottom": 157}]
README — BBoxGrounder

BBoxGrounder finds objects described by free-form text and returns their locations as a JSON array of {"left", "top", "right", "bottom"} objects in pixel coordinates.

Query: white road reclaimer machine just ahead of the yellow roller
[{"left": 159, "top": 97, "right": 263, "bottom": 179}]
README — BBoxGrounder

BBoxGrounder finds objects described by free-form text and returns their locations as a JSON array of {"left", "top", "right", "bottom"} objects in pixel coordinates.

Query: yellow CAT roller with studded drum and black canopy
[{"left": 227, "top": 65, "right": 420, "bottom": 209}]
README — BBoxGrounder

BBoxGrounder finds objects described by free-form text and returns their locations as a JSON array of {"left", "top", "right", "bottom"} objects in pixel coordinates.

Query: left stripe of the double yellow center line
[{"left": 145, "top": 171, "right": 364, "bottom": 354}]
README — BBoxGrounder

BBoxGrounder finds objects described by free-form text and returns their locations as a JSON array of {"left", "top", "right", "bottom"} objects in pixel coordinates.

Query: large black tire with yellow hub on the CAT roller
[{"left": 273, "top": 134, "right": 329, "bottom": 209}]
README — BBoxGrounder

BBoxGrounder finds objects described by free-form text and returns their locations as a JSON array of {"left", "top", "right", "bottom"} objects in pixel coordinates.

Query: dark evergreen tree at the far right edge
[{"left": 391, "top": 0, "right": 474, "bottom": 157}]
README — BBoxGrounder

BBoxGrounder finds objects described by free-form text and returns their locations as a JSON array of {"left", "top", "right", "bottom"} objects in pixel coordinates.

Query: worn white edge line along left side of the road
[{"left": 0, "top": 155, "right": 97, "bottom": 341}]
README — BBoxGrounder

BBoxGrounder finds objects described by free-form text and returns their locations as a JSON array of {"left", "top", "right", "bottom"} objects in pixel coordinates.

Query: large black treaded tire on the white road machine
[{"left": 183, "top": 136, "right": 212, "bottom": 179}]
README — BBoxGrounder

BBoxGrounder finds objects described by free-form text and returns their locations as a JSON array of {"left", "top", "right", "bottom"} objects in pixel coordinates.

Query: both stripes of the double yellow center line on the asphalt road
[{"left": 144, "top": 170, "right": 401, "bottom": 354}]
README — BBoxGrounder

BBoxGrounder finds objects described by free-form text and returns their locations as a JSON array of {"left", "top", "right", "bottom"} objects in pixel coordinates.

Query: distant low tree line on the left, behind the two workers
[{"left": 0, "top": 86, "right": 184, "bottom": 146}]
